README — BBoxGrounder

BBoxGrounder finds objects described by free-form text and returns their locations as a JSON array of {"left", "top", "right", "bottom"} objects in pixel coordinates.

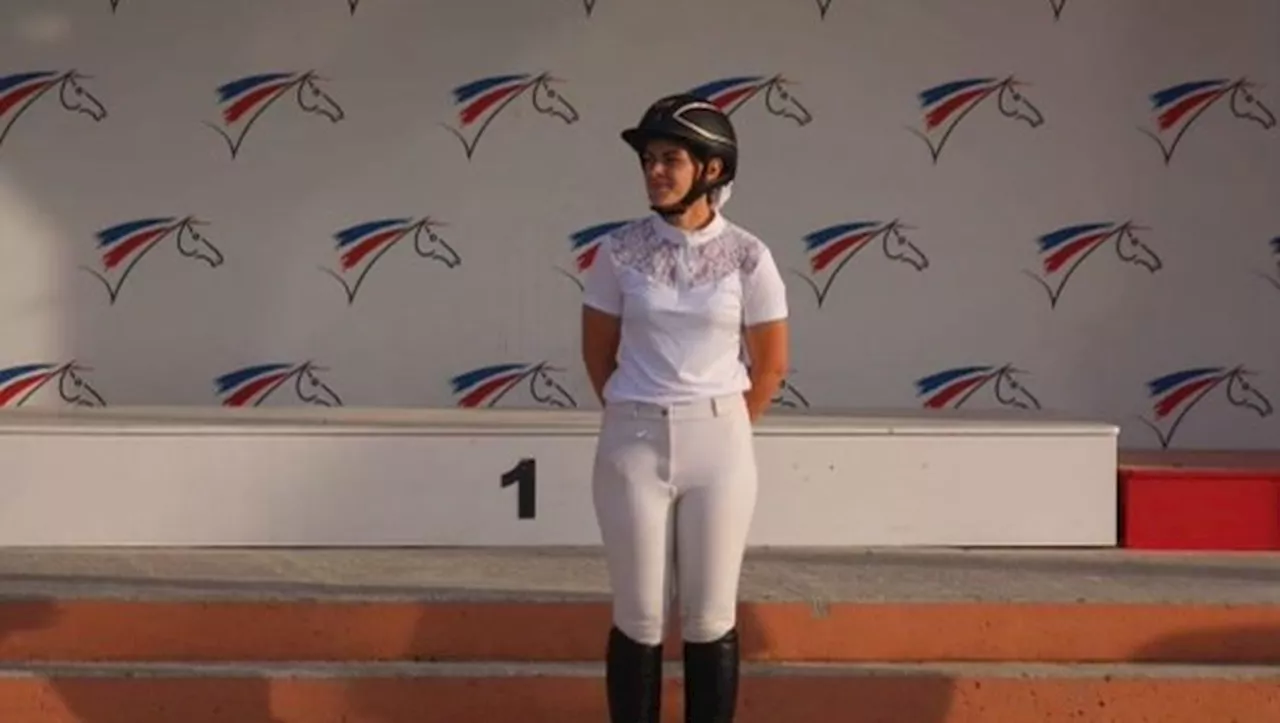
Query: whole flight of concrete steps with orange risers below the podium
[{"left": 0, "top": 549, "right": 1280, "bottom": 723}]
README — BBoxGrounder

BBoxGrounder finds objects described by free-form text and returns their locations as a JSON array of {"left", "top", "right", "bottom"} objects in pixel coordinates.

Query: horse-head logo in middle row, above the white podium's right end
[{"left": 1023, "top": 221, "right": 1164, "bottom": 308}]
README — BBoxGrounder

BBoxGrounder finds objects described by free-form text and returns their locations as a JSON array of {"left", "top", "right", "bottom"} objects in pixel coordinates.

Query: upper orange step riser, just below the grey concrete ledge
[{"left": 0, "top": 600, "right": 1280, "bottom": 665}]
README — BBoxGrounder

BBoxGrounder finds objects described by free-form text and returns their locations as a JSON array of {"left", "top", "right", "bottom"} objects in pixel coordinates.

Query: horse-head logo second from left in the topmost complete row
[{"left": 205, "top": 70, "right": 346, "bottom": 159}]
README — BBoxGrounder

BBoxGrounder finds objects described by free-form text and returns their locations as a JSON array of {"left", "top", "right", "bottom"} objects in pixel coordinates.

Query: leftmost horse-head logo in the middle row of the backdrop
[{"left": 81, "top": 216, "right": 223, "bottom": 305}]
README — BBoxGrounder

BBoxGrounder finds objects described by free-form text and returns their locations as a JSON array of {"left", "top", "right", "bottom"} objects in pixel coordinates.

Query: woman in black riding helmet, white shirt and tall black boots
[{"left": 582, "top": 95, "right": 787, "bottom": 723}]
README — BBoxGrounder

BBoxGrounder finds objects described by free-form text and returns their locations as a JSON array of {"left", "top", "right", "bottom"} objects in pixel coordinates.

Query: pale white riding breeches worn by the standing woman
[{"left": 591, "top": 394, "right": 758, "bottom": 645}]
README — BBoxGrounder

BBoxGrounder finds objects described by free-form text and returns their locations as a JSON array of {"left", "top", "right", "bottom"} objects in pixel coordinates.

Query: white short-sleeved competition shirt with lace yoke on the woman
[{"left": 582, "top": 212, "right": 787, "bottom": 404}]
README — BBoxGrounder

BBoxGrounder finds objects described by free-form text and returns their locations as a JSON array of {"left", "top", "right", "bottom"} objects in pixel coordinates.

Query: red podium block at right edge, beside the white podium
[{"left": 1119, "top": 453, "right": 1280, "bottom": 550}]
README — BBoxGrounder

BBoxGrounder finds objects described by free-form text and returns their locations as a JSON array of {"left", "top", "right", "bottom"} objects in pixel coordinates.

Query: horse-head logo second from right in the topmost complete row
[{"left": 908, "top": 75, "right": 1044, "bottom": 163}]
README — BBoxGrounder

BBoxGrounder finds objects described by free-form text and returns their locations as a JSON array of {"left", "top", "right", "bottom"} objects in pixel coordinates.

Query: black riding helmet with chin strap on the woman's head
[{"left": 622, "top": 93, "right": 737, "bottom": 215}]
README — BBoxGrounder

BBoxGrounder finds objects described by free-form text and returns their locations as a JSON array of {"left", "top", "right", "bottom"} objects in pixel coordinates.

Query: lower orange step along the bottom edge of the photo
[{"left": 0, "top": 664, "right": 1280, "bottom": 723}]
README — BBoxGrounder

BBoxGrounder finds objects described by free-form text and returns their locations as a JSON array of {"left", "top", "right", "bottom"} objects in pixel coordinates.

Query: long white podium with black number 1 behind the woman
[{"left": 0, "top": 399, "right": 1119, "bottom": 546}]
